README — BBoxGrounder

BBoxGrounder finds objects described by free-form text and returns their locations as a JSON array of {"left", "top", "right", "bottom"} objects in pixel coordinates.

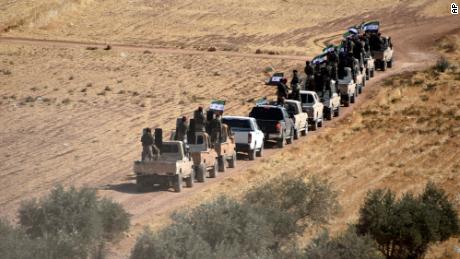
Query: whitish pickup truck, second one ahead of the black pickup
[{"left": 300, "top": 91, "right": 324, "bottom": 130}]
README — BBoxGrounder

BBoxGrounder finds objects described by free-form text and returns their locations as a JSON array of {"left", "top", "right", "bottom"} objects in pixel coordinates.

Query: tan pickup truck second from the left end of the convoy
[{"left": 188, "top": 132, "right": 218, "bottom": 182}]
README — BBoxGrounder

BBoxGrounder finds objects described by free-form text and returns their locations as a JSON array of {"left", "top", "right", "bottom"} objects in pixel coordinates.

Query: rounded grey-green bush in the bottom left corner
[{"left": 19, "top": 186, "right": 130, "bottom": 258}]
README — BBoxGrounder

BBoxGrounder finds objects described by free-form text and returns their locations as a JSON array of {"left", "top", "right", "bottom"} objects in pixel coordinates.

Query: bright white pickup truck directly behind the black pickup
[{"left": 222, "top": 116, "right": 265, "bottom": 160}]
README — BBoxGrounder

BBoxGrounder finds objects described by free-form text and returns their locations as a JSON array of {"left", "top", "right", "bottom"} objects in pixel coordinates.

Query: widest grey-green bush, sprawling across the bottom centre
[{"left": 131, "top": 178, "right": 338, "bottom": 259}]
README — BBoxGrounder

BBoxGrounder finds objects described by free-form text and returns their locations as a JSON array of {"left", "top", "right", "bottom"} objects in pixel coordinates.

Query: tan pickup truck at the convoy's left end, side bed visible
[{"left": 133, "top": 141, "right": 194, "bottom": 192}]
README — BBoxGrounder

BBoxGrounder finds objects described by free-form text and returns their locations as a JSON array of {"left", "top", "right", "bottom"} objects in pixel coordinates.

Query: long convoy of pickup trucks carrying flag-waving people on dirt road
[{"left": 134, "top": 21, "right": 393, "bottom": 192}]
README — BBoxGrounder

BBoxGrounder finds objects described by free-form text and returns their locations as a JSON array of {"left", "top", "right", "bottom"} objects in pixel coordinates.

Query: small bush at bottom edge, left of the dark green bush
[{"left": 305, "top": 227, "right": 383, "bottom": 259}]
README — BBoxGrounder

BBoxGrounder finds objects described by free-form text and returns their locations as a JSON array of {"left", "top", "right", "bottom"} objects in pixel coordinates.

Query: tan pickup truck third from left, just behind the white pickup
[{"left": 213, "top": 124, "right": 236, "bottom": 172}]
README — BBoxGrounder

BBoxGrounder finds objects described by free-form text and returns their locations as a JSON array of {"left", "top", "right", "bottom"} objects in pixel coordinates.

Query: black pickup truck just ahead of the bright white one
[{"left": 249, "top": 105, "right": 295, "bottom": 148}]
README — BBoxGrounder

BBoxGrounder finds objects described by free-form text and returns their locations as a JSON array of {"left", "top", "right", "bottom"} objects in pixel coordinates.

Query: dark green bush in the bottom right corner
[{"left": 357, "top": 183, "right": 460, "bottom": 258}]
